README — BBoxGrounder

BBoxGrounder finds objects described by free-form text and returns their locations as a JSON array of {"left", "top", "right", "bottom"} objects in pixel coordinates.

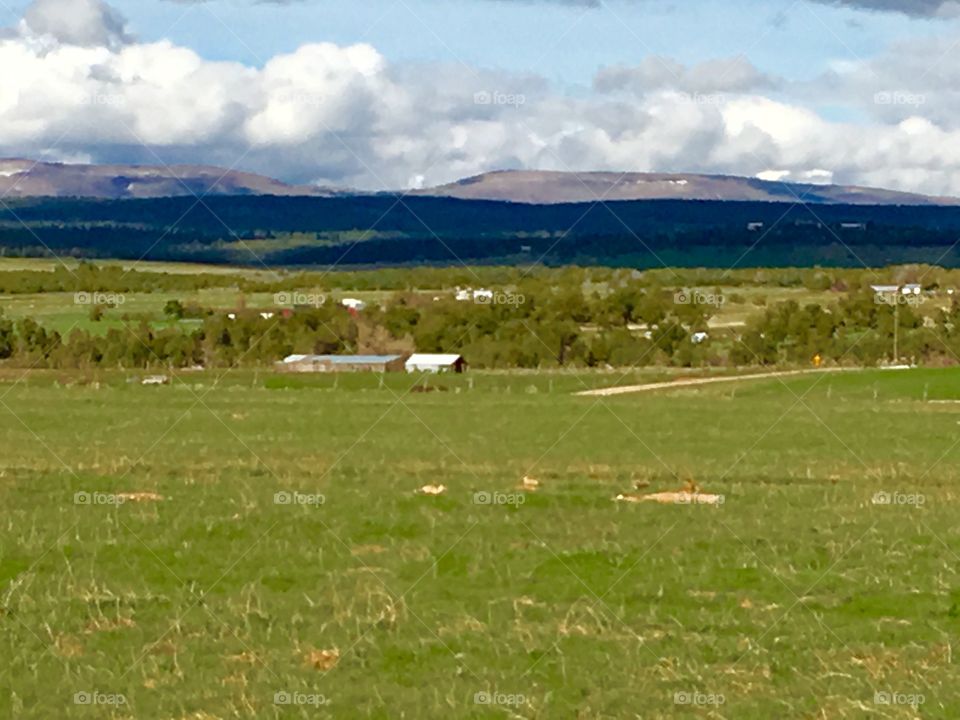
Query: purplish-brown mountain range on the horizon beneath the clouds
[{"left": 0, "top": 159, "right": 960, "bottom": 205}]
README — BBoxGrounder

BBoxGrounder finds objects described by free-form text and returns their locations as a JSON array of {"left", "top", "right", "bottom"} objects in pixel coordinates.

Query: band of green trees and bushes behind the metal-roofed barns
[{"left": 0, "top": 268, "right": 960, "bottom": 368}]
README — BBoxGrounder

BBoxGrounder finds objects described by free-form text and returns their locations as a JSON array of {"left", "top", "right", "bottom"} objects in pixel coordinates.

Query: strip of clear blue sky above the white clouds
[{"left": 73, "top": 0, "right": 944, "bottom": 85}]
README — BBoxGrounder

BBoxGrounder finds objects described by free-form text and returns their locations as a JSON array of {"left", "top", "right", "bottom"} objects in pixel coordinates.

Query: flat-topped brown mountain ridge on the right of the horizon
[{"left": 415, "top": 170, "right": 960, "bottom": 205}]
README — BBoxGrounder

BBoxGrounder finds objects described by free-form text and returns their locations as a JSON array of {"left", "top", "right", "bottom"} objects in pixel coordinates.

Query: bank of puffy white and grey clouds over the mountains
[{"left": 0, "top": 0, "right": 960, "bottom": 195}]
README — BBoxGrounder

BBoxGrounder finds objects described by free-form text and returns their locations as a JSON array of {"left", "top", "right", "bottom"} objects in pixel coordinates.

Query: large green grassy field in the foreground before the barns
[{"left": 0, "top": 370, "right": 960, "bottom": 720}]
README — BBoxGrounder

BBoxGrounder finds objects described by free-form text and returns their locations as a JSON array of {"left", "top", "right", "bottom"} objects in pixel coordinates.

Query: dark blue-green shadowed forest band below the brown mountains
[{"left": 0, "top": 194, "right": 960, "bottom": 269}]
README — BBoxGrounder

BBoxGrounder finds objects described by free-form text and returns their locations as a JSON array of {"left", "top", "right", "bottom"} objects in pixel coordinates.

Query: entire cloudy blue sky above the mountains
[{"left": 0, "top": 0, "right": 960, "bottom": 195}]
